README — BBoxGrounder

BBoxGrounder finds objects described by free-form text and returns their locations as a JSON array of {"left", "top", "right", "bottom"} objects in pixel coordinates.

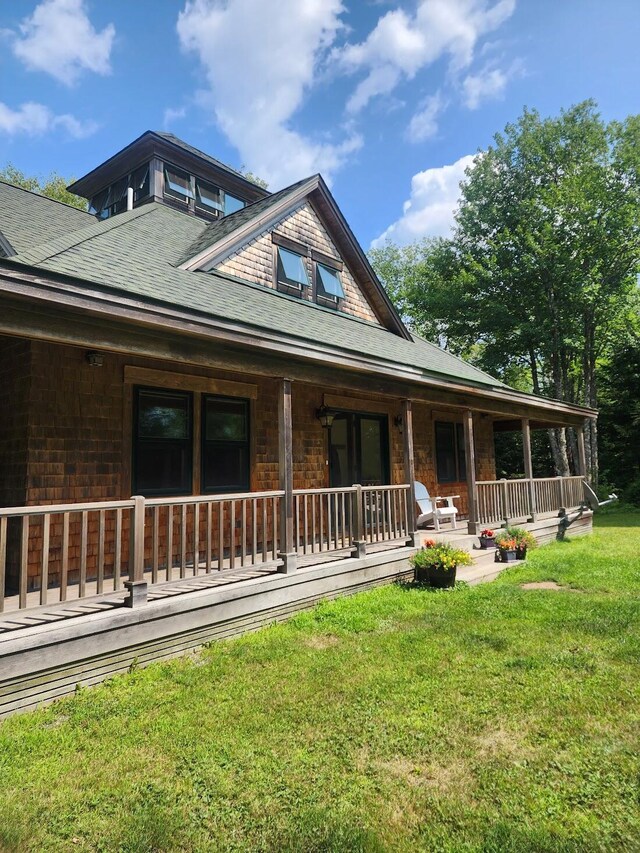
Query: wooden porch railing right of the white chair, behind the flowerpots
[{"left": 476, "top": 477, "right": 584, "bottom": 524}]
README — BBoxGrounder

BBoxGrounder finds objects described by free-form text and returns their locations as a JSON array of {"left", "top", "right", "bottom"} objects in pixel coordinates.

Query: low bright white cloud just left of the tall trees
[{"left": 371, "top": 154, "right": 474, "bottom": 247}]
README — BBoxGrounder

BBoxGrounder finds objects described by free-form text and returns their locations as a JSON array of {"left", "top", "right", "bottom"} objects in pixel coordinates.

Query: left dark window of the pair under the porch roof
[{"left": 133, "top": 388, "right": 193, "bottom": 497}]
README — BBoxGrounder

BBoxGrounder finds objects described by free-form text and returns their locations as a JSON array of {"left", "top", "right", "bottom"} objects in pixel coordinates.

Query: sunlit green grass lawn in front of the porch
[{"left": 0, "top": 512, "right": 640, "bottom": 853}]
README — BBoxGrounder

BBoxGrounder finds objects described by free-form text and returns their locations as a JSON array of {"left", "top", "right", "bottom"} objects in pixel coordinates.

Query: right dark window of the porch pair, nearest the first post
[{"left": 202, "top": 396, "right": 250, "bottom": 492}]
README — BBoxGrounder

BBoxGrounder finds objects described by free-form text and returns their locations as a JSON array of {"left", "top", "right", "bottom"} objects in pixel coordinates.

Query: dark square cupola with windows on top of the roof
[{"left": 68, "top": 130, "right": 269, "bottom": 221}]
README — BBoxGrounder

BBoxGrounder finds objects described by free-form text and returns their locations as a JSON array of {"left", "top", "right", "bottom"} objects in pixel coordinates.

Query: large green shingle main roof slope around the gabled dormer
[{"left": 5, "top": 189, "right": 502, "bottom": 386}]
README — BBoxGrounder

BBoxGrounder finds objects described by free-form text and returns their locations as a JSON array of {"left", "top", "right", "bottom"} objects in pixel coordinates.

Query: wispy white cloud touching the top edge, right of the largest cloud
[{"left": 334, "top": 0, "right": 516, "bottom": 113}]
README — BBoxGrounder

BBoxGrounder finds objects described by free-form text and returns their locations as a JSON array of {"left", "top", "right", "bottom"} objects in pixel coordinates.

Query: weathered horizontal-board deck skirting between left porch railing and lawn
[{"left": 0, "top": 548, "right": 413, "bottom": 718}]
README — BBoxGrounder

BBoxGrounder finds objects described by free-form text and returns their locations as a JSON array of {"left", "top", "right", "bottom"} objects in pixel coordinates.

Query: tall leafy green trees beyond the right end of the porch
[{"left": 373, "top": 101, "right": 640, "bottom": 474}]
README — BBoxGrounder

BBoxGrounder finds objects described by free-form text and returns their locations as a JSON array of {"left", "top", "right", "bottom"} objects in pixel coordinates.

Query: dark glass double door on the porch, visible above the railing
[{"left": 329, "top": 412, "right": 389, "bottom": 488}]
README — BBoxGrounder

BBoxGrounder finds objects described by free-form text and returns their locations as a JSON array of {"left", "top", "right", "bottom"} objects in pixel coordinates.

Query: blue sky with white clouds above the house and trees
[{"left": 0, "top": 0, "right": 640, "bottom": 249}]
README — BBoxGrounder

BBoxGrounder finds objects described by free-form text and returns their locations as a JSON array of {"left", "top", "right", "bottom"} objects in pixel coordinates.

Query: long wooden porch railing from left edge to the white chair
[{"left": 0, "top": 485, "right": 412, "bottom": 612}]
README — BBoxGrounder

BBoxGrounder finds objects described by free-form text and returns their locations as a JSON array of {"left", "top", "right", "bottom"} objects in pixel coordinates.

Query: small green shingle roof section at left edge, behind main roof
[{"left": 0, "top": 181, "right": 95, "bottom": 253}]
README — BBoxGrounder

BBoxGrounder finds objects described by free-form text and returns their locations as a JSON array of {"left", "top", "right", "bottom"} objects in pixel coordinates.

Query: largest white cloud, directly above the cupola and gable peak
[{"left": 177, "top": 0, "right": 362, "bottom": 188}]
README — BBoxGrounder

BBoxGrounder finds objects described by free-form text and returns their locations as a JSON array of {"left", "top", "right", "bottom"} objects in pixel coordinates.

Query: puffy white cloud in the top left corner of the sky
[{"left": 13, "top": 0, "right": 115, "bottom": 86}]
